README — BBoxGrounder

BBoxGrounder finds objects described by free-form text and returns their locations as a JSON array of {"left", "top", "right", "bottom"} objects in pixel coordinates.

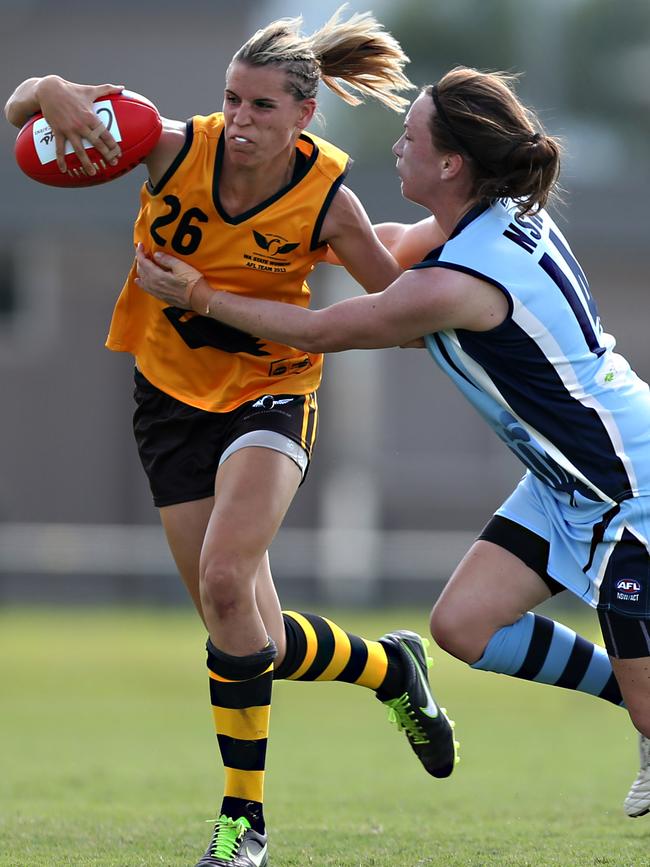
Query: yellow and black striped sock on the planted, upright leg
[{"left": 207, "top": 639, "right": 277, "bottom": 834}]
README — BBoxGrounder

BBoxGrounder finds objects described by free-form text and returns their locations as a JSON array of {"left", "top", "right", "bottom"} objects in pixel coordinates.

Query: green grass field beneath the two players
[{"left": 0, "top": 609, "right": 650, "bottom": 867}]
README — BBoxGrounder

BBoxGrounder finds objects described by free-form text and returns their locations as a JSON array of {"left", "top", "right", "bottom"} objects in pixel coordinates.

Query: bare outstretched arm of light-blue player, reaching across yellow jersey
[{"left": 136, "top": 245, "right": 508, "bottom": 353}]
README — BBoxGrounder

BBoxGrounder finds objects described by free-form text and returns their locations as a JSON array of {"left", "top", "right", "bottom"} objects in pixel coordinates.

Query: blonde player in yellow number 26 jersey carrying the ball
[{"left": 5, "top": 6, "right": 456, "bottom": 867}]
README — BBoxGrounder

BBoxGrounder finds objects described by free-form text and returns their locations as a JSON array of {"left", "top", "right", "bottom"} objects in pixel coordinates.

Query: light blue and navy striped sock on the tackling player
[{"left": 471, "top": 611, "right": 623, "bottom": 706}]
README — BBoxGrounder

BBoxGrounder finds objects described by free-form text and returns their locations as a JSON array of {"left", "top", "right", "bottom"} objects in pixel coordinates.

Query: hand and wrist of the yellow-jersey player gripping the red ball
[{"left": 5, "top": 75, "right": 124, "bottom": 175}]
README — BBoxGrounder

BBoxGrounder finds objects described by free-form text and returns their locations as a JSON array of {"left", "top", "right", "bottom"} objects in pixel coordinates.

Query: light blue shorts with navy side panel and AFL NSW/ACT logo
[{"left": 496, "top": 473, "right": 650, "bottom": 620}]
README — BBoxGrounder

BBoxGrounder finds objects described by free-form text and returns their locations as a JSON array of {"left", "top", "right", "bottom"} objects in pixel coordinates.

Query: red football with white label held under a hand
[{"left": 14, "top": 90, "right": 162, "bottom": 187}]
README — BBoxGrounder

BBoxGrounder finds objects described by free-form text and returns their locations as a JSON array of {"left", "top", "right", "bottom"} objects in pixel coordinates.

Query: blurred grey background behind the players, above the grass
[{"left": 0, "top": 0, "right": 650, "bottom": 604}]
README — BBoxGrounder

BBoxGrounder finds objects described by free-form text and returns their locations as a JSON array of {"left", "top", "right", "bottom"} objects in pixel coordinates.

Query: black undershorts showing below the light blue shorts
[{"left": 478, "top": 515, "right": 650, "bottom": 659}]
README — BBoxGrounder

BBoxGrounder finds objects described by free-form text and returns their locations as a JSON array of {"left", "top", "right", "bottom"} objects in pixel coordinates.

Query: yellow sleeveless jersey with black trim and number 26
[{"left": 106, "top": 113, "right": 349, "bottom": 412}]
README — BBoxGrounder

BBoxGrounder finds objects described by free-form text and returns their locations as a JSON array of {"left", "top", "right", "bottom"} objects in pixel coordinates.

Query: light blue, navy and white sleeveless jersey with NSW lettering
[{"left": 414, "top": 201, "right": 650, "bottom": 520}]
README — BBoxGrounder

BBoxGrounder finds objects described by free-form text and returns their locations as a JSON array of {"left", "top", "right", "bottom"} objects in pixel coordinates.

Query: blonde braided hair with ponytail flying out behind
[{"left": 231, "top": 6, "right": 414, "bottom": 112}]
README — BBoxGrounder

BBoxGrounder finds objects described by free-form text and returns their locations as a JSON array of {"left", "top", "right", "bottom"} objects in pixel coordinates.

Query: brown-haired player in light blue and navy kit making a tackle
[{"left": 139, "top": 68, "right": 650, "bottom": 816}]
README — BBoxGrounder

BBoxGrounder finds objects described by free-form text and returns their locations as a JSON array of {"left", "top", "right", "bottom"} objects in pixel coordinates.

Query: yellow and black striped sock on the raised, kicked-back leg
[{"left": 273, "top": 611, "right": 402, "bottom": 695}]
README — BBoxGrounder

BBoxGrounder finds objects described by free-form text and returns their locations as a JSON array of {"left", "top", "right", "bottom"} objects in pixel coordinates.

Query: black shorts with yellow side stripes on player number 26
[{"left": 133, "top": 369, "right": 318, "bottom": 508}]
